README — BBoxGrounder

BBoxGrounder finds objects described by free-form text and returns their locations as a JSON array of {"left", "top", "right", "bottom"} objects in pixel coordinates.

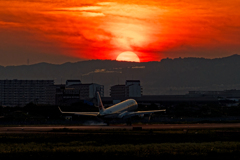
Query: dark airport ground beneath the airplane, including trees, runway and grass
[{"left": 0, "top": 106, "right": 240, "bottom": 160}]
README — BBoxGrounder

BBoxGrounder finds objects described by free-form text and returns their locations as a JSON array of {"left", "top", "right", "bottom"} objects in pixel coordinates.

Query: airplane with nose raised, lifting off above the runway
[{"left": 58, "top": 92, "right": 166, "bottom": 125}]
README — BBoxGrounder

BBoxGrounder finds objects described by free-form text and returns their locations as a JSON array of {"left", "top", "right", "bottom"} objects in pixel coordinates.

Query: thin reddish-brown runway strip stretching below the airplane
[{"left": 0, "top": 123, "right": 240, "bottom": 133}]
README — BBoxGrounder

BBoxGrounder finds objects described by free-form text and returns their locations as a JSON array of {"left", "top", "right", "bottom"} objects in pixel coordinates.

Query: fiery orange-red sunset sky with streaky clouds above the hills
[{"left": 0, "top": 0, "right": 240, "bottom": 66}]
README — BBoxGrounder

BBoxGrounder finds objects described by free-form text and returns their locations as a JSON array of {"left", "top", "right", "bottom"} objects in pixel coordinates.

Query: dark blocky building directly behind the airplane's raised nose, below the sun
[{"left": 110, "top": 80, "right": 142, "bottom": 98}]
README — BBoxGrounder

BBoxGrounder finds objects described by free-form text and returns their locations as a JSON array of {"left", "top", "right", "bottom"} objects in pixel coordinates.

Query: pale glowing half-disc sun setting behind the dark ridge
[{"left": 116, "top": 51, "right": 140, "bottom": 62}]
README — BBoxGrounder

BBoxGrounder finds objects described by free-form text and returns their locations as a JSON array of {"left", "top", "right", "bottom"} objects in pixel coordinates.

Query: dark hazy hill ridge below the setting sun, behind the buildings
[{"left": 0, "top": 55, "right": 240, "bottom": 96}]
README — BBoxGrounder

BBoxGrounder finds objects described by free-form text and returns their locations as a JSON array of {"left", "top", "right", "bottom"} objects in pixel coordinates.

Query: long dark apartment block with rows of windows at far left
[{"left": 0, "top": 79, "right": 56, "bottom": 106}]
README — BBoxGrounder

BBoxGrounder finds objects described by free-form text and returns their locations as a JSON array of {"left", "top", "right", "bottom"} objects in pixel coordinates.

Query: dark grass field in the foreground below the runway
[{"left": 0, "top": 129, "right": 240, "bottom": 160}]
